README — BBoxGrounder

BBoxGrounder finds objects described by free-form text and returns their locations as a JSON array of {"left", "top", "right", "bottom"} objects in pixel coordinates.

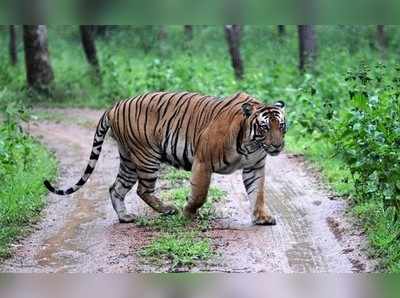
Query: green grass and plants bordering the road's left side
[{"left": 0, "top": 103, "right": 55, "bottom": 257}]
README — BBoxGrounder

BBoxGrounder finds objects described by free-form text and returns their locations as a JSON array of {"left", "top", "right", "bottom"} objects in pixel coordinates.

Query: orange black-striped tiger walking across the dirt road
[{"left": 44, "top": 92, "right": 287, "bottom": 225}]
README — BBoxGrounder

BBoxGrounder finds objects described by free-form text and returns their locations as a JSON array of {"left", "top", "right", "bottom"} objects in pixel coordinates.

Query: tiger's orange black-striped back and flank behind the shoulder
[{"left": 109, "top": 92, "right": 255, "bottom": 170}]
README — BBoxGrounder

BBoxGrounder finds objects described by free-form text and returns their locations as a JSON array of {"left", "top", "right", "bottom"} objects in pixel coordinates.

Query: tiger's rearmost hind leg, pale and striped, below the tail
[{"left": 110, "top": 155, "right": 137, "bottom": 223}]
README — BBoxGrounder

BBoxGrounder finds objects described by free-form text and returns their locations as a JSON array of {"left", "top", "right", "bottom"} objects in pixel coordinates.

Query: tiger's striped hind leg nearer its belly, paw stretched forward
[{"left": 137, "top": 163, "right": 178, "bottom": 215}]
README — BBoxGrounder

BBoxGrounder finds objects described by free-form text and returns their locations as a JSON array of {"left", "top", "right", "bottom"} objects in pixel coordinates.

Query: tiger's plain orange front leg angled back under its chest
[{"left": 183, "top": 160, "right": 211, "bottom": 218}]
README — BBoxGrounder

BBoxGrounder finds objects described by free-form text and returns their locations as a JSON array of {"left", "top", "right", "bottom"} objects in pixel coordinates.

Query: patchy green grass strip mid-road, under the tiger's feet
[{"left": 136, "top": 181, "right": 226, "bottom": 269}]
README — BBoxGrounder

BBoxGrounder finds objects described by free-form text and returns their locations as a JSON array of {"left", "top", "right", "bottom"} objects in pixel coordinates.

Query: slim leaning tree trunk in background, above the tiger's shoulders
[{"left": 225, "top": 25, "right": 244, "bottom": 80}]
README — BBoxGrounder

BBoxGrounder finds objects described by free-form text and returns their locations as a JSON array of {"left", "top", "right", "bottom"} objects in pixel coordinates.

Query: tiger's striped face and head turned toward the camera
[{"left": 242, "top": 101, "right": 287, "bottom": 156}]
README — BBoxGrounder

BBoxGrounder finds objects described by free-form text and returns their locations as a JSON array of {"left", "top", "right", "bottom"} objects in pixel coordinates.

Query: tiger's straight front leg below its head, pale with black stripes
[{"left": 242, "top": 161, "right": 276, "bottom": 225}]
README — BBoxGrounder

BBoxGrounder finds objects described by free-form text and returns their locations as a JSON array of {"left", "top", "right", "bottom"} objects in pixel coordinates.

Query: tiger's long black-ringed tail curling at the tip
[{"left": 44, "top": 112, "right": 110, "bottom": 196}]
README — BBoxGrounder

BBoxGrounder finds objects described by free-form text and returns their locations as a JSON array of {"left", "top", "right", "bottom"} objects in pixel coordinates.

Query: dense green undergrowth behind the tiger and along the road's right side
[{"left": 0, "top": 26, "right": 400, "bottom": 271}]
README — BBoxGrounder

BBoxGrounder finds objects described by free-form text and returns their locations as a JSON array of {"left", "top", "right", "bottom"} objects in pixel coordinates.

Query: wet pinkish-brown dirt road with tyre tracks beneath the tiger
[{"left": 0, "top": 109, "right": 375, "bottom": 272}]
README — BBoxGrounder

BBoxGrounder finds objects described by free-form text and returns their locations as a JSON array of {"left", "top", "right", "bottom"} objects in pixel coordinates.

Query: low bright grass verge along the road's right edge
[{"left": 287, "top": 126, "right": 400, "bottom": 272}]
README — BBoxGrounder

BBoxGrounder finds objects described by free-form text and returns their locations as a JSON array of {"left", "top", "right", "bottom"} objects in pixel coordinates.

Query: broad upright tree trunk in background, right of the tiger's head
[{"left": 297, "top": 25, "right": 317, "bottom": 72}]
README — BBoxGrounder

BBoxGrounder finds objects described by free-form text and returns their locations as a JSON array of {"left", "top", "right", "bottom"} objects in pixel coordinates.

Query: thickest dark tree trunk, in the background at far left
[{"left": 23, "top": 25, "right": 54, "bottom": 91}]
